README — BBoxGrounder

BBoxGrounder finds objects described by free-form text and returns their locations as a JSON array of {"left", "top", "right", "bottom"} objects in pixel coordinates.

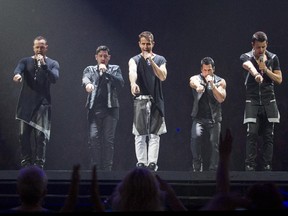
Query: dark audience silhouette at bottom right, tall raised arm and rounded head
[{"left": 201, "top": 129, "right": 285, "bottom": 211}]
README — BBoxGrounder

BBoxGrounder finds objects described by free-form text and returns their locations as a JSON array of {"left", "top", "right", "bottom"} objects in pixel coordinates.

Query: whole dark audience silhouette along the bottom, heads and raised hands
[{"left": 2, "top": 129, "right": 286, "bottom": 213}]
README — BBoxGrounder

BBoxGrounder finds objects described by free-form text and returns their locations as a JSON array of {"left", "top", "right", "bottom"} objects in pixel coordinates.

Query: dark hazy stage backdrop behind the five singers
[{"left": 0, "top": 0, "right": 288, "bottom": 171}]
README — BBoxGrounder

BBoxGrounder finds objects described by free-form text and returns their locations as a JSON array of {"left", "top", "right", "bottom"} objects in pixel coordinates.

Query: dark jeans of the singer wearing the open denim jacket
[{"left": 88, "top": 108, "right": 118, "bottom": 171}]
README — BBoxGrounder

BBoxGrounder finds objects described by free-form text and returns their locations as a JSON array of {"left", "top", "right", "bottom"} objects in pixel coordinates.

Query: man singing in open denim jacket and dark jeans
[{"left": 82, "top": 46, "right": 124, "bottom": 171}]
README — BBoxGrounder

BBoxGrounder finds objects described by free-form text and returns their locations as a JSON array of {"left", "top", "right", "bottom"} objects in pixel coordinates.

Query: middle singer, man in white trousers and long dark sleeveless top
[{"left": 128, "top": 31, "right": 167, "bottom": 171}]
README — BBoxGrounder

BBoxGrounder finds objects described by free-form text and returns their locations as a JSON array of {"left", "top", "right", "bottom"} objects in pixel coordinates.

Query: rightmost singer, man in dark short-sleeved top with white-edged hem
[{"left": 240, "top": 31, "right": 282, "bottom": 171}]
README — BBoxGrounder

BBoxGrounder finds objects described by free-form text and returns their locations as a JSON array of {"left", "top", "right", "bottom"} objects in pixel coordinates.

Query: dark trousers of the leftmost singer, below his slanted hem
[{"left": 20, "top": 121, "right": 48, "bottom": 168}]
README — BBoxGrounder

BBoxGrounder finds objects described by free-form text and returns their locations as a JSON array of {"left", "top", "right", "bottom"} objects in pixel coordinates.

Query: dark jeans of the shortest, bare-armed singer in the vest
[{"left": 191, "top": 120, "right": 221, "bottom": 171}]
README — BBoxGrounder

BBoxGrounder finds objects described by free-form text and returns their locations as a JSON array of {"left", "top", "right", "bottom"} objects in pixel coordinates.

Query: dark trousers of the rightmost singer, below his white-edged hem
[{"left": 245, "top": 108, "right": 274, "bottom": 168}]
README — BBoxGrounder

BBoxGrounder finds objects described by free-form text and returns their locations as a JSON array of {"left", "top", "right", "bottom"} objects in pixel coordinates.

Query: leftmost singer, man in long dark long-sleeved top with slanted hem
[{"left": 13, "top": 36, "right": 59, "bottom": 168}]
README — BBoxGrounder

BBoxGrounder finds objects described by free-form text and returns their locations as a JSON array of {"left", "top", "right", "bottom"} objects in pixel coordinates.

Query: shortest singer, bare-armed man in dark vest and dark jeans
[{"left": 189, "top": 57, "right": 226, "bottom": 172}]
